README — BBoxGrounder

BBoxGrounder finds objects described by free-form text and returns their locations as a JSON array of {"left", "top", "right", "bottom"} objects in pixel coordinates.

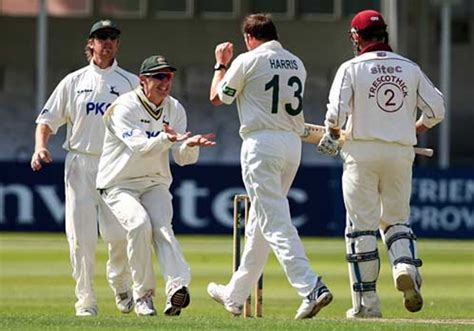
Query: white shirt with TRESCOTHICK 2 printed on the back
[{"left": 325, "top": 51, "right": 445, "bottom": 146}]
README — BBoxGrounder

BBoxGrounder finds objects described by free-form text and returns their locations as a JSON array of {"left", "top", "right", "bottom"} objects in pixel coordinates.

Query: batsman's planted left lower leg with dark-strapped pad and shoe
[{"left": 346, "top": 227, "right": 381, "bottom": 317}]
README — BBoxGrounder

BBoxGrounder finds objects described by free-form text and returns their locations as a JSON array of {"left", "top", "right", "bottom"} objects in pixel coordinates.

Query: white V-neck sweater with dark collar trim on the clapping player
[{"left": 97, "top": 87, "right": 199, "bottom": 189}]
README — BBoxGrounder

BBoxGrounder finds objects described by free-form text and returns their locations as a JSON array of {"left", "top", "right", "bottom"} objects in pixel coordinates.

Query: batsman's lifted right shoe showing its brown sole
[{"left": 395, "top": 270, "right": 423, "bottom": 313}]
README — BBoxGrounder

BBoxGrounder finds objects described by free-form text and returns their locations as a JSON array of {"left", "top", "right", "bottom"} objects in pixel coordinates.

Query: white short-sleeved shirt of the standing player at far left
[{"left": 36, "top": 61, "right": 139, "bottom": 155}]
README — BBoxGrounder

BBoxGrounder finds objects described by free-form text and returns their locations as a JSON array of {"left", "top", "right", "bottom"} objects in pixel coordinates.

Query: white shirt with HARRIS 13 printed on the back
[{"left": 218, "top": 40, "right": 306, "bottom": 138}]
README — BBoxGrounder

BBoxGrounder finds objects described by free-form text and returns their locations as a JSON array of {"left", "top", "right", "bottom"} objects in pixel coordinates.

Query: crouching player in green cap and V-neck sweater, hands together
[{"left": 97, "top": 55, "right": 215, "bottom": 316}]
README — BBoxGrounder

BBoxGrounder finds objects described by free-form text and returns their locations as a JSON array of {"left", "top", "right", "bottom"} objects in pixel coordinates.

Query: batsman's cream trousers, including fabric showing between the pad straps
[{"left": 341, "top": 141, "right": 416, "bottom": 312}]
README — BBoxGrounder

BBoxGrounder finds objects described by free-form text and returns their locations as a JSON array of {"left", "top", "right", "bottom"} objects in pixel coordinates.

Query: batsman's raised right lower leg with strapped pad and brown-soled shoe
[{"left": 382, "top": 224, "right": 423, "bottom": 312}]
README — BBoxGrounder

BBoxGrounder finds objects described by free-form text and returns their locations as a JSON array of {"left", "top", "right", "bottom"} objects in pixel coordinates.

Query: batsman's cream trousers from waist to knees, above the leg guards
[{"left": 341, "top": 141, "right": 415, "bottom": 232}]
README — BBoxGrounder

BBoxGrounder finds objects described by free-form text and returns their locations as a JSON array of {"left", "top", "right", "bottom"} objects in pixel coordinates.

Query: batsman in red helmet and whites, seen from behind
[{"left": 318, "top": 10, "right": 444, "bottom": 318}]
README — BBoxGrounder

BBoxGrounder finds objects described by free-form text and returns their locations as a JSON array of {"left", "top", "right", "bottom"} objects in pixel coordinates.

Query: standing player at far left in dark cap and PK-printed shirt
[{"left": 31, "top": 20, "right": 138, "bottom": 316}]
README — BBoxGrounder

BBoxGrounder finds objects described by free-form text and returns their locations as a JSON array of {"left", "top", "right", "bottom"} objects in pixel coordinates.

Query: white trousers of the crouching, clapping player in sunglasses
[{"left": 102, "top": 179, "right": 191, "bottom": 299}]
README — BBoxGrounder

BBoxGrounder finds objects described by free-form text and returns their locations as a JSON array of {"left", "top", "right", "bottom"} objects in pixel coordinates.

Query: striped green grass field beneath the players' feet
[{"left": 0, "top": 232, "right": 474, "bottom": 331}]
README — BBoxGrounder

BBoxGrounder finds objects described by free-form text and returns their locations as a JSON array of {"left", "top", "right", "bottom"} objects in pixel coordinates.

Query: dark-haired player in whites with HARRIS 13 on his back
[{"left": 208, "top": 14, "right": 332, "bottom": 319}]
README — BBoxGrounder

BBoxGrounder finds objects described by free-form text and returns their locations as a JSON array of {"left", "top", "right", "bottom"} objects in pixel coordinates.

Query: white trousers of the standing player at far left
[{"left": 64, "top": 152, "right": 130, "bottom": 310}]
